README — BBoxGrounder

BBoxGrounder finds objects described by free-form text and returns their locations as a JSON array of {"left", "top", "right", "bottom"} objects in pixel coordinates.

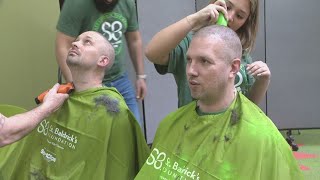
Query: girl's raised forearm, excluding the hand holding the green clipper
[{"left": 145, "top": 15, "right": 192, "bottom": 65}]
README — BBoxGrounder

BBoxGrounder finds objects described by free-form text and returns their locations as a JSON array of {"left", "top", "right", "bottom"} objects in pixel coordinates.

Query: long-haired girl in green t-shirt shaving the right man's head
[{"left": 145, "top": 0, "right": 271, "bottom": 107}]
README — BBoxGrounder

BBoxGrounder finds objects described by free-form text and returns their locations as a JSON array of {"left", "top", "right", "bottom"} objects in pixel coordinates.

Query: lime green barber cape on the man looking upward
[{"left": 0, "top": 87, "right": 149, "bottom": 180}]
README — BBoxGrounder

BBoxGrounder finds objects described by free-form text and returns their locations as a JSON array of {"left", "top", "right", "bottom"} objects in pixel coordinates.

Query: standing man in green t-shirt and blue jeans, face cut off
[{"left": 56, "top": 0, "right": 147, "bottom": 126}]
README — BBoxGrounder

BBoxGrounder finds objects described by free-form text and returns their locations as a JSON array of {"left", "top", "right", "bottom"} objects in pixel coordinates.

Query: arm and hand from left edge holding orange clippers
[{"left": 0, "top": 84, "right": 68, "bottom": 147}]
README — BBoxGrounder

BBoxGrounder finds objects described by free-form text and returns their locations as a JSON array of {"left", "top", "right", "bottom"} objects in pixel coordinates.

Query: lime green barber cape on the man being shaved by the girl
[{"left": 135, "top": 93, "right": 304, "bottom": 180}]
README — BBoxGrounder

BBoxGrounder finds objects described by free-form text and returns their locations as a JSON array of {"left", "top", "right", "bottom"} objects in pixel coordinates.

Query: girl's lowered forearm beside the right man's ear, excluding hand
[{"left": 248, "top": 79, "right": 270, "bottom": 105}]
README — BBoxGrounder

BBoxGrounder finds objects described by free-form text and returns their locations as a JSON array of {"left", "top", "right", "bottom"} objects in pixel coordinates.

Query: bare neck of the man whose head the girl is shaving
[{"left": 197, "top": 89, "right": 237, "bottom": 113}]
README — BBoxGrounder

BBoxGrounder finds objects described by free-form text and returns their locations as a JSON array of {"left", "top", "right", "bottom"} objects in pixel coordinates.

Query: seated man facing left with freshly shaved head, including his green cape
[{"left": 135, "top": 25, "right": 303, "bottom": 180}]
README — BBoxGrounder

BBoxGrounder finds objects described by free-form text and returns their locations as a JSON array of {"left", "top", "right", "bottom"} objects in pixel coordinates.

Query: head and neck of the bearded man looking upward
[{"left": 66, "top": 31, "right": 115, "bottom": 90}]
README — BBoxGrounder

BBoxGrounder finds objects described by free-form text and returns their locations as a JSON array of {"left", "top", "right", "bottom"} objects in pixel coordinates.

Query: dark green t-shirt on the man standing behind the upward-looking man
[{"left": 57, "top": 0, "right": 139, "bottom": 83}]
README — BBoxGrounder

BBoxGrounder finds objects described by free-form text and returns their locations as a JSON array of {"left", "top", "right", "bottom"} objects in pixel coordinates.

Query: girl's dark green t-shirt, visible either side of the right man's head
[{"left": 155, "top": 33, "right": 254, "bottom": 107}]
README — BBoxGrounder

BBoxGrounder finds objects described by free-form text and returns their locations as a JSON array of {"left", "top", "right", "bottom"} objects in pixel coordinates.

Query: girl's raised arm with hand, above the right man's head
[{"left": 145, "top": 1, "right": 227, "bottom": 65}]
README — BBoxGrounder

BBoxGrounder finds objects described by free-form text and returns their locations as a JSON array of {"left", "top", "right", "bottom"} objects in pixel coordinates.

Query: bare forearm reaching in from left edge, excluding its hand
[{"left": 0, "top": 105, "right": 51, "bottom": 147}]
